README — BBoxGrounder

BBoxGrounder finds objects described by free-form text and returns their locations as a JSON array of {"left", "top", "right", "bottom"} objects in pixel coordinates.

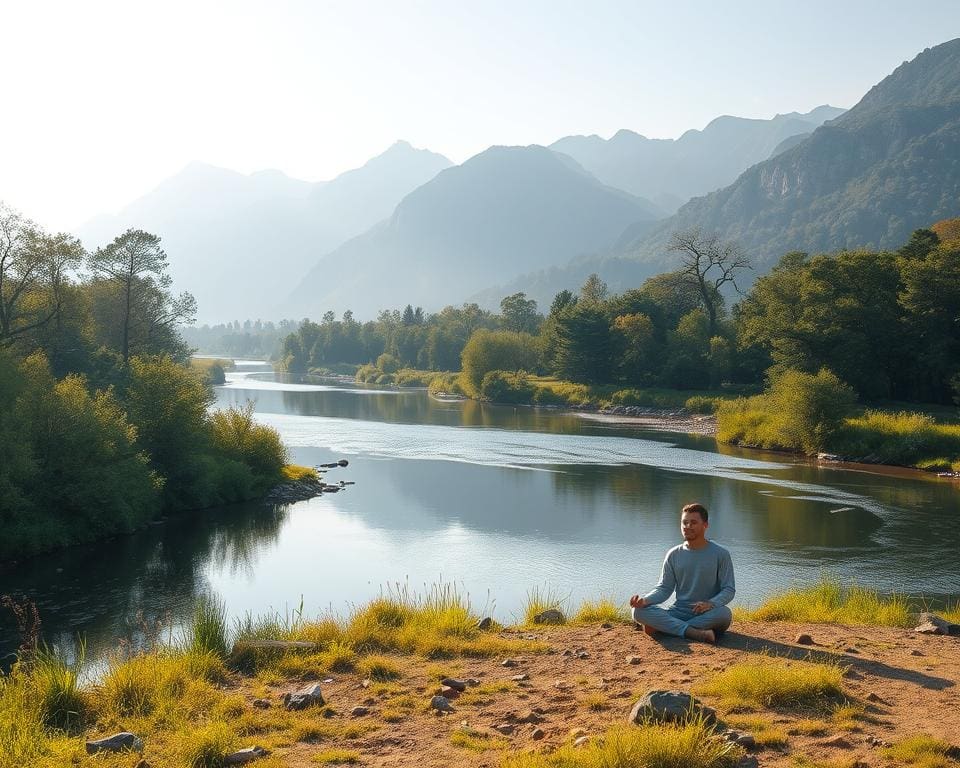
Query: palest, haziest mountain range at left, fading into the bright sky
[{"left": 77, "top": 142, "right": 451, "bottom": 322}]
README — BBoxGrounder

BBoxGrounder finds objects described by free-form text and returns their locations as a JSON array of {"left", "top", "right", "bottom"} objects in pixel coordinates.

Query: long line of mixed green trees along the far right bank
[{"left": 280, "top": 220, "right": 960, "bottom": 412}]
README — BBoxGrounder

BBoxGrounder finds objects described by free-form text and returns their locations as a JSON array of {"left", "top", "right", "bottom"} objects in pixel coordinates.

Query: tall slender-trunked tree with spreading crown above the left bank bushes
[{"left": 90, "top": 229, "right": 196, "bottom": 364}]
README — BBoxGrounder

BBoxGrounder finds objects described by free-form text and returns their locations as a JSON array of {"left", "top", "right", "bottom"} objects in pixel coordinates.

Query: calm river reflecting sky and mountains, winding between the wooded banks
[{"left": 0, "top": 365, "right": 960, "bottom": 658}]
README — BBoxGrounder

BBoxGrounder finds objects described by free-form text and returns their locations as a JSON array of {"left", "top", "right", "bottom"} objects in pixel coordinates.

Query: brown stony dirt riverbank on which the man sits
[{"left": 60, "top": 622, "right": 960, "bottom": 768}]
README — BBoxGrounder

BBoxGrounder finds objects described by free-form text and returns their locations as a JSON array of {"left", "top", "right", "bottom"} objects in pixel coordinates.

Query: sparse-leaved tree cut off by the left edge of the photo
[{"left": 0, "top": 203, "right": 83, "bottom": 347}]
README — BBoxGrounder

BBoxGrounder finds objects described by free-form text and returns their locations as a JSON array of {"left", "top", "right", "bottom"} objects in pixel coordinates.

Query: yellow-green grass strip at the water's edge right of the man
[{"left": 737, "top": 576, "right": 914, "bottom": 627}]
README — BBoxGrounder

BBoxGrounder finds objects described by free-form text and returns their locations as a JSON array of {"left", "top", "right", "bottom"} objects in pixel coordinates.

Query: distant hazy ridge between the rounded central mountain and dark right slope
[{"left": 550, "top": 105, "right": 844, "bottom": 213}]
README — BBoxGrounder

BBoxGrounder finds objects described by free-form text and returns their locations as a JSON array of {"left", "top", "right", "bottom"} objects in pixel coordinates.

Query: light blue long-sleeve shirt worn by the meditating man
[{"left": 643, "top": 541, "right": 737, "bottom": 608}]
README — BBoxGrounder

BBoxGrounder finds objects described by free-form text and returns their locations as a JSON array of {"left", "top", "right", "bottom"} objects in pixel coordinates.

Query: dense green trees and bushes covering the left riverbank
[{"left": 0, "top": 204, "right": 285, "bottom": 560}]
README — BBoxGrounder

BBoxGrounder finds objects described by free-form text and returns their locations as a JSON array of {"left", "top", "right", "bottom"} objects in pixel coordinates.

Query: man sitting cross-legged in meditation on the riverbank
[{"left": 630, "top": 504, "right": 736, "bottom": 643}]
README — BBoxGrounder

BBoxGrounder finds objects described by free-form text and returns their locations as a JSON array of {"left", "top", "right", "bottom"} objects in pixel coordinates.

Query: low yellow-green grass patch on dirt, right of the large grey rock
[{"left": 698, "top": 658, "right": 845, "bottom": 711}]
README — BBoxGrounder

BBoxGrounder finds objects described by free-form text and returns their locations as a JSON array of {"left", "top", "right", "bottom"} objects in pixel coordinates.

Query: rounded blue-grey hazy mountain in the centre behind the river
[{"left": 289, "top": 146, "right": 659, "bottom": 318}]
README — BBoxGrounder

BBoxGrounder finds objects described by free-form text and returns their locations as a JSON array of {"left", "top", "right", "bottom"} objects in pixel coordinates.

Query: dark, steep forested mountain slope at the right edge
[{"left": 623, "top": 39, "right": 960, "bottom": 273}]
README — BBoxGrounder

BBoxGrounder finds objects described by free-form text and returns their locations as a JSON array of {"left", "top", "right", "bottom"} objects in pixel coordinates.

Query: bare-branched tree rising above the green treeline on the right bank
[{"left": 667, "top": 227, "right": 750, "bottom": 336}]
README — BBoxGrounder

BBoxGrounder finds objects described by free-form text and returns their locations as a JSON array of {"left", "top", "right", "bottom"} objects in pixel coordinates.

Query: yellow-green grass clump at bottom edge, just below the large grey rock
[{"left": 501, "top": 722, "right": 744, "bottom": 768}]
